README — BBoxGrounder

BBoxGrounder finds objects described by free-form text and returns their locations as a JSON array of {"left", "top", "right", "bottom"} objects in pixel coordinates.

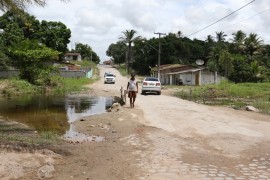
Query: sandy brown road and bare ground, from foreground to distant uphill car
[{"left": 0, "top": 66, "right": 270, "bottom": 180}]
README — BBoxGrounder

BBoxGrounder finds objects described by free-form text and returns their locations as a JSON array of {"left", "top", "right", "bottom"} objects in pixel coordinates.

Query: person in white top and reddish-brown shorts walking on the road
[{"left": 127, "top": 74, "right": 139, "bottom": 108}]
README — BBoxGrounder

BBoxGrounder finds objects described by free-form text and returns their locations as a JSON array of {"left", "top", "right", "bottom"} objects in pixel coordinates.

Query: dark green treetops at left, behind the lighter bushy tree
[{"left": 0, "top": 11, "right": 71, "bottom": 54}]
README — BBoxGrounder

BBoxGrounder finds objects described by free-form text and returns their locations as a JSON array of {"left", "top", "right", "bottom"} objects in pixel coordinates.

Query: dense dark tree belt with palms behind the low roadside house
[{"left": 107, "top": 30, "right": 270, "bottom": 83}]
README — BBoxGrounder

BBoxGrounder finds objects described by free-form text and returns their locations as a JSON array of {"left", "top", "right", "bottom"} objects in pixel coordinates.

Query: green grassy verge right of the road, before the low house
[{"left": 170, "top": 81, "right": 270, "bottom": 114}]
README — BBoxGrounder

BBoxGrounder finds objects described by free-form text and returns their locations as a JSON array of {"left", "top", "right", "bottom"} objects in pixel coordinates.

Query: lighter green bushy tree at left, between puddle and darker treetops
[{"left": 10, "top": 40, "right": 59, "bottom": 85}]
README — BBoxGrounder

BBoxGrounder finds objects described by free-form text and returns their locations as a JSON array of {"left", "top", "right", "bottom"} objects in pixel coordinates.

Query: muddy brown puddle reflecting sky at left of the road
[{"left": 0, "top": 95, "right": 113, "bottom": 142}]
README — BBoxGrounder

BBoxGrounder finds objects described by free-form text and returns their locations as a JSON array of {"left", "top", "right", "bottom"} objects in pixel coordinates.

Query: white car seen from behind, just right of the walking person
[{"left": 142, "top": 77, "right": 161, "bottom": 95}]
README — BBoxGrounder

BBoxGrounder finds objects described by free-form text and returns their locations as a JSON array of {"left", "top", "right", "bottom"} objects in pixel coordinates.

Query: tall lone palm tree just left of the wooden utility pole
[{"left": 119, "top": 29, "right": 141, "bottom": 73}]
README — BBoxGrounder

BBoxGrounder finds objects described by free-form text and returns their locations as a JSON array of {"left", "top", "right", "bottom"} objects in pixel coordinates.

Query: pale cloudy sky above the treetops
[{"left": 27, "top": 0, "right": 270, "bottom": 62}]
